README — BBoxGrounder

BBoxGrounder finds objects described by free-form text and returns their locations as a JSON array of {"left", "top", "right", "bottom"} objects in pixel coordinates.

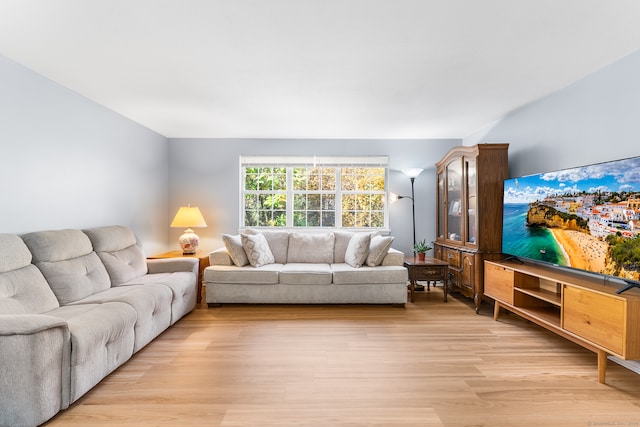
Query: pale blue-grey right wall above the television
[{"left": 464, "top": 51, "right": 640, "bottom": 177}]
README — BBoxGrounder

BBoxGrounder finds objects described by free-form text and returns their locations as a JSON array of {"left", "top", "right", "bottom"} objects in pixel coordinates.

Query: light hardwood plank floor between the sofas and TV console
[{"left": 46, "top": 287, "right": 640, "bottom": 427}]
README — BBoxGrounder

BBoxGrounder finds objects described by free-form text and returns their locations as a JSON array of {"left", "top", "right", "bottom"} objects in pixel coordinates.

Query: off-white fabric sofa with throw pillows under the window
[{"left": 204, "top": 230, "right": 408, "bottom": 307}]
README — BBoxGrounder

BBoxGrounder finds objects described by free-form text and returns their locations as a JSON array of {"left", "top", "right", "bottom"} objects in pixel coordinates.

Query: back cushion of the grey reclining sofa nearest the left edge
[{"left": 0, "top": 234, "right": 59, "bottom": 314}]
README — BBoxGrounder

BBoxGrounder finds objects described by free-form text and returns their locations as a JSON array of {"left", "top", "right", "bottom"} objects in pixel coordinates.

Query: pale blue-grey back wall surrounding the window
[{"left": 169, "top": 139, "right": 462, "bottom": 253}]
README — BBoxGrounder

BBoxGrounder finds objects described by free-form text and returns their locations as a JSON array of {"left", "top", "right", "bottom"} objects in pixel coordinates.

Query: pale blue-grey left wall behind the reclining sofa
[{"left": 0, "top": 55, "right": 169, "bottom": 253}]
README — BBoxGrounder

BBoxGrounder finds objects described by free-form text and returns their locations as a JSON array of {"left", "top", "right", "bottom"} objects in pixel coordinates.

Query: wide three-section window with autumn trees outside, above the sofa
[{"left": 240, "top": 156, "right": 388, "bottom": 228}]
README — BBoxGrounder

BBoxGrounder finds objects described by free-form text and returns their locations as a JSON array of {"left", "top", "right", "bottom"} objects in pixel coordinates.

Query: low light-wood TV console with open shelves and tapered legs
[{"left": 484, "top": 261, "right": 640, "bottom": 383}]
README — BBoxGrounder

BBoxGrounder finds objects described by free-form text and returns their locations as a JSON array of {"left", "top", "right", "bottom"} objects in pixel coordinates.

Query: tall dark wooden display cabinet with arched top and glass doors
[{"left": 434, "top": 144, "right": 509, "bottom": 313}]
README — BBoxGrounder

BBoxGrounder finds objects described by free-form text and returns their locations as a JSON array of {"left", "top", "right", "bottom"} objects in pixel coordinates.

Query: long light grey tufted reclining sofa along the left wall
[{"left": 0, "top": 226, "right": 198, "bottom": 426}]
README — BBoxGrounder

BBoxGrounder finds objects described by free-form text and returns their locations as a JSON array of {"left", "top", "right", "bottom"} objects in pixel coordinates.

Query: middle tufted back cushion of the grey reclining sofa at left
[{"left": 22, "top": 230, "right": 111, "bottom": 305}]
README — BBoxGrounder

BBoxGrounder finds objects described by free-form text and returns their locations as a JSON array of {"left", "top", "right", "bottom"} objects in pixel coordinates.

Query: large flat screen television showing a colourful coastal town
[{"left": 502, "top": 157, "right": 640, "bottom": 293}]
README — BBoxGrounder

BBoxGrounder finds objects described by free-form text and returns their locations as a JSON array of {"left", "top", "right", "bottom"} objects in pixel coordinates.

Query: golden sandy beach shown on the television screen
[{"left": 549, "top": 228, "right": 607, "bottom": 272}]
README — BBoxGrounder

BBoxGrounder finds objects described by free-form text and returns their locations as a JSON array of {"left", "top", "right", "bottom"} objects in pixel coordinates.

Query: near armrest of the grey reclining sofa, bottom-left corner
[{"left": 0, "top": 314, "right": 71, "bottom": 425}]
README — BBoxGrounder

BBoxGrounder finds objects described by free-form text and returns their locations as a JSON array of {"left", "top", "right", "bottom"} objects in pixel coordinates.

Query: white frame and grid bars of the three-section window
[{"left": 239, "top": 155, "right": 389, "bottom": 232}]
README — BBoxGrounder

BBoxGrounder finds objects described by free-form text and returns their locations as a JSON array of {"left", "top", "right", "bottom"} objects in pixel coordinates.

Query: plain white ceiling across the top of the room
[{"left": 0, "top": 0, "right": 640, "bottom": 138}]
